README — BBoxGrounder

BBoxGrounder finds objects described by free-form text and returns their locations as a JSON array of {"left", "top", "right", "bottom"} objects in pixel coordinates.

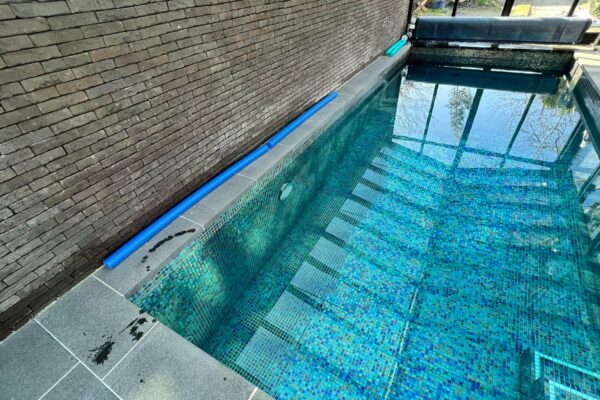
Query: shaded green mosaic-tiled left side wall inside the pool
[{"left": 131, "top": 74, "right": 398, "bottom": 348}]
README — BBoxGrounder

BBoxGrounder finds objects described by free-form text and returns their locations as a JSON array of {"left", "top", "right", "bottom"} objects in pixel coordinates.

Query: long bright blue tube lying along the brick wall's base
[{"left": 104, "top": 92, "right": 337, "bottom": 269}]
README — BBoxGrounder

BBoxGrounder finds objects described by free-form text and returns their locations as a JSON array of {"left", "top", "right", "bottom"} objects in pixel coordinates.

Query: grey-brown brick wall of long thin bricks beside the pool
[{"left": 0, "top": 0, "right": 408, "bottom": 338}]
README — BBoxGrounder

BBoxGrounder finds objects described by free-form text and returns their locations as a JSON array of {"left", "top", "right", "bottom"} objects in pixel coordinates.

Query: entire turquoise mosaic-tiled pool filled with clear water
[{"left": 132, "top": 65, "right": 600, "bottom": 399}]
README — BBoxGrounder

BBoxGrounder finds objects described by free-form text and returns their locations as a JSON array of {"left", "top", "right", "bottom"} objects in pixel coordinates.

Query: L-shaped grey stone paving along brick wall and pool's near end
[{"left": 0, "top": 43, "right": 409, "bottom": 400}]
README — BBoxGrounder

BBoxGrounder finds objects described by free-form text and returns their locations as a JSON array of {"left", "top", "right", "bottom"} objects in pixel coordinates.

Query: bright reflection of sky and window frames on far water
[{"left": 394, "top": 66, "right": 579, "bottom": 166}]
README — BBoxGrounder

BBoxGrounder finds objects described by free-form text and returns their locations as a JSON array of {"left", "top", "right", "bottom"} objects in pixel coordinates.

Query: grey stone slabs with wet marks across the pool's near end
[{"left": 0, "top": 276, "right": 268, "bottom": 400}]
